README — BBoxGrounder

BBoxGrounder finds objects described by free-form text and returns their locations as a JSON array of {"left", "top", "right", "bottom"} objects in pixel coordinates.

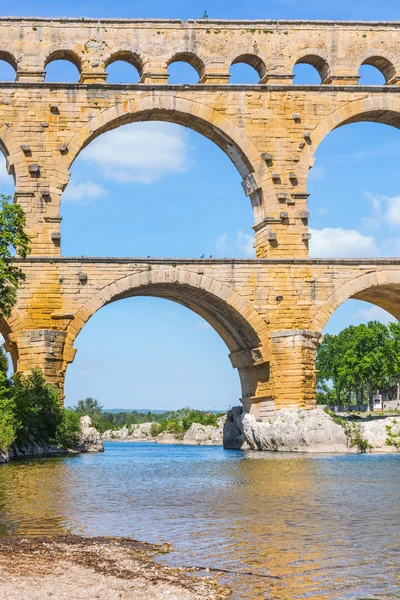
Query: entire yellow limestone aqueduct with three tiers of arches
[{"left": 0, "top": 18, "right": 400, "bottom": 417}]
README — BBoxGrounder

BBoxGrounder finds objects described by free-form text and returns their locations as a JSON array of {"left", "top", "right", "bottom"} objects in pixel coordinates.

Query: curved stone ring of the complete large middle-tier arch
[{"left": 68, "top": 94, "right": 260, "bottom": 178}]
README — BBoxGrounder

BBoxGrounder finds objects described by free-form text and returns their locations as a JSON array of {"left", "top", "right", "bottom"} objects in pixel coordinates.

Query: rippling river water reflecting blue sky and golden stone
[{"left": 0, "top": 443, "right": 400, "bottom": 600}]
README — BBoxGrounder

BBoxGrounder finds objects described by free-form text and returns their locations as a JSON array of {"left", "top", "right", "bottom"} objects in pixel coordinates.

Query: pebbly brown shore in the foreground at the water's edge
[{"left": 0, "top": 536, "right": 230, "bottom": 600}]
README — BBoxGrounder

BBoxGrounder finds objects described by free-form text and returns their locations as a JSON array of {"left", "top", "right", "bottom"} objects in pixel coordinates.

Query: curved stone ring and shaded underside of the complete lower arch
[{"left": 65, "top": 266, "right": 266, "bottom": 366}]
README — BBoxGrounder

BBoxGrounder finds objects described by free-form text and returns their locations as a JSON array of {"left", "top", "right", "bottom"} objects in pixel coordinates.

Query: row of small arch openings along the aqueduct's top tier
[{"left": 0, "top": 51, "right": 396, "bottom": 85}]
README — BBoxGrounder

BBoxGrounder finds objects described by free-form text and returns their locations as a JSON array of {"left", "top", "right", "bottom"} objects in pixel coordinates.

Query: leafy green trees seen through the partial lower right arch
[{"left": 317, "top": 321, "right": 400, "bottom": 408}]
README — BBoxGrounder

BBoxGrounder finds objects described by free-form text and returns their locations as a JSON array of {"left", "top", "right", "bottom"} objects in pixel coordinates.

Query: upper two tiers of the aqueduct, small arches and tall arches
[{"left": 0, "top": 18, "right": 400, "bottom": 258}]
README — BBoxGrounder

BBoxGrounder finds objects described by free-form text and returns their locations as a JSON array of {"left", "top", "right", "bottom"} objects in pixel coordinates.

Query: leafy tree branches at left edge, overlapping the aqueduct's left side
[{"left": 0, "top": 194, "right": 30, "bottom": 317}]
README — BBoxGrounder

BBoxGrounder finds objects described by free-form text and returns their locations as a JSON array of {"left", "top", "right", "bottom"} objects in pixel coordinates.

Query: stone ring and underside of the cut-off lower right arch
[{"left": 311, "top": 270, "right": 400, "bottom": 331}]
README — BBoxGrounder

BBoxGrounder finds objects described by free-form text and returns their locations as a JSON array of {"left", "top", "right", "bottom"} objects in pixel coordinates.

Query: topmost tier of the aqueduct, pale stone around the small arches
[{"left": 0, "top": 17, "right": 400, "bottom": 85}]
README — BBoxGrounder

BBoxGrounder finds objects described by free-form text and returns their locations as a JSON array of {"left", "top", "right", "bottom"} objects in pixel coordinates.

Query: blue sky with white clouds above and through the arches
[{"left": 0, "top": 0, "right": 400, "bottom": 409}]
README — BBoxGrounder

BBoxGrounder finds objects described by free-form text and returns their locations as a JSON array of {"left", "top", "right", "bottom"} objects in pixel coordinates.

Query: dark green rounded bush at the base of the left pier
[{"left": 13, "top": 369, "right": 63, "bottom": 443}]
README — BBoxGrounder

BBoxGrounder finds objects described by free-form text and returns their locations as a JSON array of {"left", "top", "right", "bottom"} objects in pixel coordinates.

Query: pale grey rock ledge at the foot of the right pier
[{"left": 224, "top": 407, "right": 400, "bottom": 452}]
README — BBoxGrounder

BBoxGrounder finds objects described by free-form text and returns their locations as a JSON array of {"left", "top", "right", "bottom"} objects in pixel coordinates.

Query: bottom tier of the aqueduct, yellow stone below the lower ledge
[{"left": 3, "top": 257, "right": 400, "bottom": 414}]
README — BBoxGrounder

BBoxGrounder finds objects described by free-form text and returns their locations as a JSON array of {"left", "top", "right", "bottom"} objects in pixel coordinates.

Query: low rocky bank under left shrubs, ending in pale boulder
[{"left": 0, "top": 417, "right": 104, "bottom": 463}]
